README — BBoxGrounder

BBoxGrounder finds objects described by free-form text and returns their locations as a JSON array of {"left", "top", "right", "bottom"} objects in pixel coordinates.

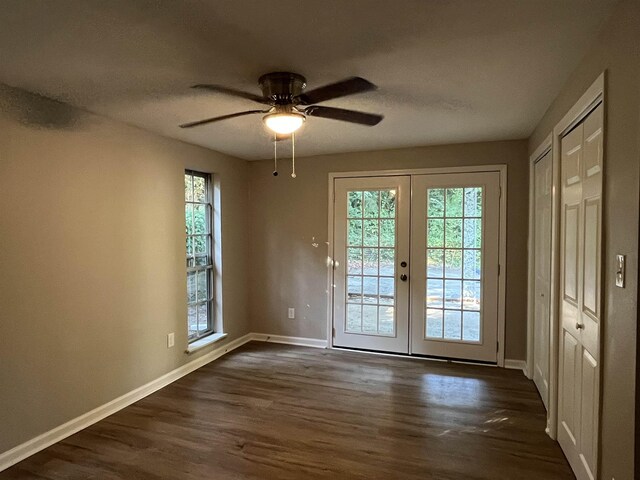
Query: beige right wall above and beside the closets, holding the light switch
[{"left": 529, "top": 0, "right": 640, "bottom": 480}]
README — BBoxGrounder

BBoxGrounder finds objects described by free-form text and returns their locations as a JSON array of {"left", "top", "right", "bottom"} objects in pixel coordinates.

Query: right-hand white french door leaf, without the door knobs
[{"left": 411, "top": 172, "right": 500, "bottom": 362}]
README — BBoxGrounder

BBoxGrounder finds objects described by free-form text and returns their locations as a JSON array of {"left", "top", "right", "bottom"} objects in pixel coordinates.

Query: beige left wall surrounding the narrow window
[{"left": 0, "top": 87, "right": 249, "bottom": 452}]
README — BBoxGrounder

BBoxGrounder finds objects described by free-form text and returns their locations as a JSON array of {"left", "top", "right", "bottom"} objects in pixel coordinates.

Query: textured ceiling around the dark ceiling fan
[{"left": 0, "top": 0, "right": 615, "bottom": 159}]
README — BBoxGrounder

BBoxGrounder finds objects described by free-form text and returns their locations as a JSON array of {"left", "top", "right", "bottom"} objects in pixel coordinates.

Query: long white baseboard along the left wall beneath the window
[{"left": 0, "top": 333, "right": 253, "bottom": 472}]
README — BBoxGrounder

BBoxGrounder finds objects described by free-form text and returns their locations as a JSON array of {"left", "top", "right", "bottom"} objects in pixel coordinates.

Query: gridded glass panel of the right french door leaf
[{"left": 425, "top": 186, "right": 484, "bottom": 343}]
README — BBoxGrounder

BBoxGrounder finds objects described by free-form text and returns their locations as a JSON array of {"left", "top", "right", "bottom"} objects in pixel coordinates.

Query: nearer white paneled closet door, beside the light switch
[{"left": 558, "top": 105, "right": 603, "bottom": 480}]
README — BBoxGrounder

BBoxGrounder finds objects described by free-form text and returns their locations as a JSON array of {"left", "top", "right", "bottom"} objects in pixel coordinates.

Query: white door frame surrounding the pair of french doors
[{"left": 327, "top": 165, "right": 507, "bottom": 367}]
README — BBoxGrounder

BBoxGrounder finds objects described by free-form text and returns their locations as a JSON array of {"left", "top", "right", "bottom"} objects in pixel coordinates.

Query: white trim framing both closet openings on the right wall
[{"left": 527, "top": 72, "right": 606, "bottom": 440}]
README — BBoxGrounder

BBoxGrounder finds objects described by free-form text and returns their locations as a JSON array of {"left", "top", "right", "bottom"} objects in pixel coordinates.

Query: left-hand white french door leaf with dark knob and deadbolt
[{"left": 333, "top": 176, "right": 411, "bottom": 353}]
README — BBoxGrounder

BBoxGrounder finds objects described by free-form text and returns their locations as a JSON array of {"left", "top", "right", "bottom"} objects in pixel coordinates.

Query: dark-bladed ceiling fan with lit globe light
[{"left": 180, "top": 72, "right": 384, "bottom": 136}]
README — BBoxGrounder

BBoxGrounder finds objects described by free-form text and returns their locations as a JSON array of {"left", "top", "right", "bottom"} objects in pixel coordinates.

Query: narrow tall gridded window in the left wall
[{"left": 184, "top": 170, "right": 213, "bottom": 342}]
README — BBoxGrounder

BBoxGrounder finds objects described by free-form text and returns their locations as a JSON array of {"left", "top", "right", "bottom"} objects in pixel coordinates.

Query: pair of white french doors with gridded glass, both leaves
[{"left": 333, "top": 172, "right": 500, "bottom": 362}]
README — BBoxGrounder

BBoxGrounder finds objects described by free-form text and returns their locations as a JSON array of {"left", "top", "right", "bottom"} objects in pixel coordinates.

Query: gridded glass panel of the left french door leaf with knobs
[{"left": 345, "top": 189, "right": 397, "bottom": 336}]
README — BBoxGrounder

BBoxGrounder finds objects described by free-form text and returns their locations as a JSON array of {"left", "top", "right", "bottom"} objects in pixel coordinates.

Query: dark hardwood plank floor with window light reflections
[{"left": 0, "top": 343, "right": 574, "bottom": 480}]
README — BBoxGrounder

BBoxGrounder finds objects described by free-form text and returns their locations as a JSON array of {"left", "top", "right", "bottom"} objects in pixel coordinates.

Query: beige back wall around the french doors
[{"left": 250, "top": 138, "right": 528, "bottom": 359}]
